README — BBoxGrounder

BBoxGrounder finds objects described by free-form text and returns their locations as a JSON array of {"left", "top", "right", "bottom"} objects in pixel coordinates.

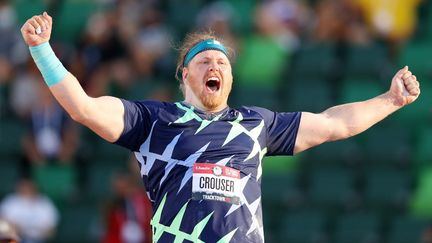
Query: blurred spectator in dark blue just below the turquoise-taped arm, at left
[{"left": 24, "top": 82, "right": 78, "bottom": 165}]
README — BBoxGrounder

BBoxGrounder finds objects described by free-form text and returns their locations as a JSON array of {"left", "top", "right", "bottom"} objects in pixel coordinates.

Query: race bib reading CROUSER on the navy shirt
[{"left": 192, "top": 163, "right": 241, "bottom": 205}]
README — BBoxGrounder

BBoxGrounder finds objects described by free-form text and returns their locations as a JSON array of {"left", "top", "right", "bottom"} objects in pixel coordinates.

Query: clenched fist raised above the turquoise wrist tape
[{"left": 21, "top": 12, "right": 52, "bottom": 46}]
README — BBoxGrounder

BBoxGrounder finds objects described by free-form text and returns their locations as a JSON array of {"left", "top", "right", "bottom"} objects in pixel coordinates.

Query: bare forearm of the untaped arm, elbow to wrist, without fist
[{"left": 323, "top": 92, "right": 402, "bottom": 141}]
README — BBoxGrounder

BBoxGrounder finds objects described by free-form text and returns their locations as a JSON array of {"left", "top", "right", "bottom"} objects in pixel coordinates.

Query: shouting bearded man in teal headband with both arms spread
[{"left": 21, "top": 13, "right": 420, "bottom": 242}]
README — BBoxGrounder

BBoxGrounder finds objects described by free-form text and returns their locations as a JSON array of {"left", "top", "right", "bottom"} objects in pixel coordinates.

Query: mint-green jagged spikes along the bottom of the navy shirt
[{"left": 151, "top": 194, "right": 237, "bottom": 243}]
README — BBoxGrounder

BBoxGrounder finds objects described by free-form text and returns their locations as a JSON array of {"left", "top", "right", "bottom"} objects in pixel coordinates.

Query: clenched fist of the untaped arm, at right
[{"left": 390, "top": 66, "right": 420, "bottom": 106}]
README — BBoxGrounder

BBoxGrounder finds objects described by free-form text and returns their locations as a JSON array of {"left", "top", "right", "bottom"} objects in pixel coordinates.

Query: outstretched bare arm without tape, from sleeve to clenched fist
[{"left": 294, "top": 67, "right": 420, "bottom": 153}]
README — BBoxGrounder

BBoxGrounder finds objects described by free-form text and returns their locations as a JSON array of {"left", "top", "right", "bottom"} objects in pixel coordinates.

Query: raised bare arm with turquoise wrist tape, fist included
[{"left": 21, "top": 12, "right": 124, "bottom": 142}]
